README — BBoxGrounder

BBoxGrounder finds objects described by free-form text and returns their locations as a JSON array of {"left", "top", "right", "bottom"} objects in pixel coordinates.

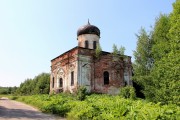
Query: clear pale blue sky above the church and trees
[{"left": 0, "top": 0, "right": 175, "bottom": 87}]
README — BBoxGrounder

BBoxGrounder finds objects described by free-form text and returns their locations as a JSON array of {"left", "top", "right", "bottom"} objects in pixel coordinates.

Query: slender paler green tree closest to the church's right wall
[{"left": 133, "top": 28, "right": 153, "bottom": 85}]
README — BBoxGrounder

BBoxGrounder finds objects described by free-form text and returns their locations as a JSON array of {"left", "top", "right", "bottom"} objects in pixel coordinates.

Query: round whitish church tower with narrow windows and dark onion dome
[{"left": 77, "top": 20, "right": 100, "bottom": 49}]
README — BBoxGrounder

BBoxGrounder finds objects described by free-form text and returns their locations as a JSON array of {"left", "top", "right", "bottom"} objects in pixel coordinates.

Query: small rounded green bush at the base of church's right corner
[{"left": 119, "top": 86, "right": 136, "bottom": 99}]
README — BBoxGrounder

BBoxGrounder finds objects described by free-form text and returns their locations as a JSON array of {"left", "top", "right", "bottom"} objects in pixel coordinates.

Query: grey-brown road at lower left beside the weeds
[{"left": 0, "top": 97, "right": 63, "bottom": 120}]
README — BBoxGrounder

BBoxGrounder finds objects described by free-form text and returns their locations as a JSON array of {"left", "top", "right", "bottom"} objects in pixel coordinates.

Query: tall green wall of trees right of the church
[{"left": 133, "top": 0, "right": 180, "bottom": 104}]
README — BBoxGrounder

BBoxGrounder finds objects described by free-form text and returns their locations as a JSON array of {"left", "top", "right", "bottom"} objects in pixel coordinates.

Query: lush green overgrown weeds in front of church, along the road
[{"left": 10, "top": 94, "right": 180, "bottom": 120}]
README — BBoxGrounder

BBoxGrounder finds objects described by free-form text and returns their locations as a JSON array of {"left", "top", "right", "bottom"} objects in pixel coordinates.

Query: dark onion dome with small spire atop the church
[{"left": 77, "top": 21, "right": 100, "bottom": 37}]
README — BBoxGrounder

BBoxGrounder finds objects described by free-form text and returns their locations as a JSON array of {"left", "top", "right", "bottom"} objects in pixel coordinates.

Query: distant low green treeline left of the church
[{"left": 0, "top": 73, "right": 50, "bottom": 95}]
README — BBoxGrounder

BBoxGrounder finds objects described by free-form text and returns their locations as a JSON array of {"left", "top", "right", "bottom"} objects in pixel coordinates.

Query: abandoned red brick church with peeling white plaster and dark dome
[{"left": 50, "top": 21, "right": 132, "bottom": 94}]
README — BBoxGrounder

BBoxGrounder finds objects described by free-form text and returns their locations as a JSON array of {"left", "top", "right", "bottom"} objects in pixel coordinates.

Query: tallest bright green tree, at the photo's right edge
[{"left": 146, "top": 0, "right": 180, "bottom": 105}]
